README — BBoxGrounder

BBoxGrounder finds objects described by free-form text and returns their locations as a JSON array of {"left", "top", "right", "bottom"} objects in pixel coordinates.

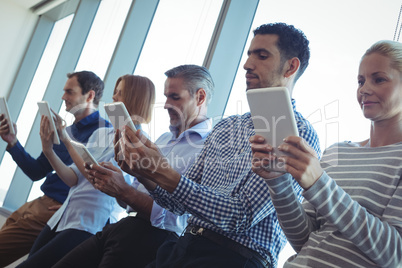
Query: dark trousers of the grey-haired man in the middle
[{"left": 54, "top": 217, "right": 177, "bottom": 268}]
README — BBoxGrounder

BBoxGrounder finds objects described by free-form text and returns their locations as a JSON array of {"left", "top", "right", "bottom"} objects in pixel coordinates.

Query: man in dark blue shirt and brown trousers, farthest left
[{"left": 0, "top": 71, "right": 111, "bottom": 267}]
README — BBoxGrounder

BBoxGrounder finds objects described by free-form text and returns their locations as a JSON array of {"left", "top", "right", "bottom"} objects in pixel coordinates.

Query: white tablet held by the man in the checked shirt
[{"left": 105, "top": 102, "right": 137, "bottom": 131}]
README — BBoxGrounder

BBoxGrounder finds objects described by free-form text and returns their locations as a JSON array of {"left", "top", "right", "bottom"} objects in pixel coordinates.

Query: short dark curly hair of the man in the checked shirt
[{"left": 254, "top": 22, "right": 310, "bottom": 81}]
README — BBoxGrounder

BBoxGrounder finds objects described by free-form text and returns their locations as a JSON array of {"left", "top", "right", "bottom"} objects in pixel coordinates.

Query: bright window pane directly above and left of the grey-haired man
[{"left": 135, "top": 0, "right": 223, "bottom": 140}]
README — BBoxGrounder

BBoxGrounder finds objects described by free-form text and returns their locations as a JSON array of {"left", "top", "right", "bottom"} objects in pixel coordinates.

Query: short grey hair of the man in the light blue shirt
[{"left": 165, "top": 64, "right": 215, "bottom": 104}]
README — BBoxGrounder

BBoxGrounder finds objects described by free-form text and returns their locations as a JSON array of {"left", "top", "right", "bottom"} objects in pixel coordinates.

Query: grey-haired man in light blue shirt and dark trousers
[{"left": 54, "top": 65, "right": 214, "bottom": 267}]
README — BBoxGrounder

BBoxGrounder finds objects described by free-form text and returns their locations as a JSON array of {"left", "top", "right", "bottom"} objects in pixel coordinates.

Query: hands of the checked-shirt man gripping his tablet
[{"left": 115, "top": 127, "right": 181, "bottom": 192}]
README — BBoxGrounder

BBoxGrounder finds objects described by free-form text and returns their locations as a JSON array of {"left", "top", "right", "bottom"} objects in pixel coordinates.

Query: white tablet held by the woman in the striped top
[{"left": 247, "top": 87, "right": 299, "bottom": 172}]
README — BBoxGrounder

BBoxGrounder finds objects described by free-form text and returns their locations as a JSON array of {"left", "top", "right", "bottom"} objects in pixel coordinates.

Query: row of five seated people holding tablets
[{"left": 0, "top": 23, "right": 402, "bottom": 267}]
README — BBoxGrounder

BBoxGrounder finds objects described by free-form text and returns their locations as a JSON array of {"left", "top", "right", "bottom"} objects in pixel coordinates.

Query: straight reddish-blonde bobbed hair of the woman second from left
[{"left": 113, "top": 74, "right": 155, "bottom": 124}]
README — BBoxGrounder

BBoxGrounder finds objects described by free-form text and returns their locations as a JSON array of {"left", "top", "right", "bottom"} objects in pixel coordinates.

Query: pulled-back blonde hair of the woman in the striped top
[{"left": 362, "top": 40, "right": 402, "bottom": 75}]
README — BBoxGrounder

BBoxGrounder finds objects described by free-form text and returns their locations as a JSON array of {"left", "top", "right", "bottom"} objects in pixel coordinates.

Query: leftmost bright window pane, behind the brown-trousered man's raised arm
[{"left": 0, "top": 15, "right": 74, "bottom": 205}]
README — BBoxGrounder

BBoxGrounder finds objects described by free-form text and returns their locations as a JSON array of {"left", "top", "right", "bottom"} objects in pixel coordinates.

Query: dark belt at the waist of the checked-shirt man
[{"left": 185, "top": 224, "right": 270, "bottom": 267}]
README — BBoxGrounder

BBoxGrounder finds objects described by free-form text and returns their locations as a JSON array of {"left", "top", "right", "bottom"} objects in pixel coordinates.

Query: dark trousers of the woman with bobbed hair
[{"left": 17, "top": 225, "right": 93, "bottom": 268}]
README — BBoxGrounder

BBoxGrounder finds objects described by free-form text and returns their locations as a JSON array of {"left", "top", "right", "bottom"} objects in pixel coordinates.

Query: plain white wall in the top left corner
[{"left": 0, "top": 0, "right": 38, "bottom": 97}]
